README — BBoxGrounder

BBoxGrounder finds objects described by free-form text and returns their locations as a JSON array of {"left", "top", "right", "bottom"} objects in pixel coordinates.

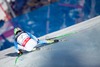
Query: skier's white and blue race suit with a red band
[{"left": 14, "top": 32, "right": 47, "bottom": 53}]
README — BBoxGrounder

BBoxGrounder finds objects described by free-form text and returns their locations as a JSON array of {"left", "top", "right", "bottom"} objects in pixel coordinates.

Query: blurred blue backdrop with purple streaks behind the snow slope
[{"left": 0, "top": 0, "right": 100, "bottom": 51}]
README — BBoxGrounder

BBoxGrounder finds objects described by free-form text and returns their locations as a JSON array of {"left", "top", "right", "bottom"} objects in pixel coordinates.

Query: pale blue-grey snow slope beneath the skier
[{"left": 0, "top": 16, "right": 100, "bottom": 67}]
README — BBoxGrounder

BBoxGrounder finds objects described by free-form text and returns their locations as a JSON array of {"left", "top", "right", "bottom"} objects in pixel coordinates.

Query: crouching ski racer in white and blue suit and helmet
[{"left": 14, "top": 27, "right": 59, "bottom": 56}]
